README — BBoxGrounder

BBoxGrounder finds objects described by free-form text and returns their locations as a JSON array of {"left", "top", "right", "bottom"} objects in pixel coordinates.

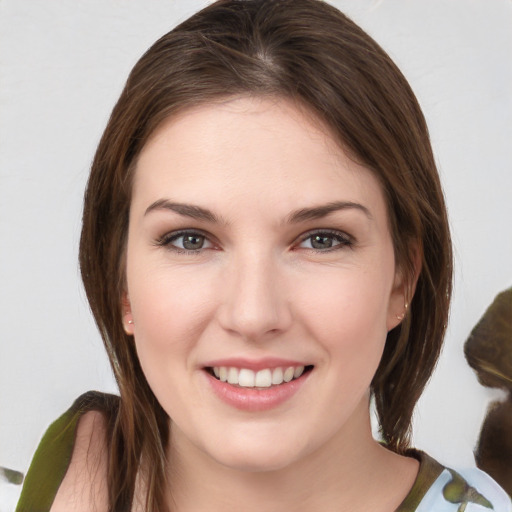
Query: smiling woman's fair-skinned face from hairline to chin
[{"left": 124, "top": 98, "right": 404, "bottom": 471}]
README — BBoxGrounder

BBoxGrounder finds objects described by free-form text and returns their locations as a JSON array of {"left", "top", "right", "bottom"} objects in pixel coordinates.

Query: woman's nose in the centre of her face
[{"left": 218, "top": 253, "right": 292, "bottom": 341}]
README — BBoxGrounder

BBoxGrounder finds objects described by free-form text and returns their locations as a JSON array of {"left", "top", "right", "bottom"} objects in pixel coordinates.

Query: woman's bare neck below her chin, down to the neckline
[{"left": 169, "top": 403, "right": 418, "bottom": 512}]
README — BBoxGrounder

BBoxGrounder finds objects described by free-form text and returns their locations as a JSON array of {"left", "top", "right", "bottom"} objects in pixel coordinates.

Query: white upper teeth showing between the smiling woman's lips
[{"left": 205, "top": 365, "right": 313, "bottom": 389}]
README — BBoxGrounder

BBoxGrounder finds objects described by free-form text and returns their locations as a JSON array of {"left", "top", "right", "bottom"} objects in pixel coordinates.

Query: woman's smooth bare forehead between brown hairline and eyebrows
[{"left": 132, "top": 97, "right": 383, "bottom": 222}]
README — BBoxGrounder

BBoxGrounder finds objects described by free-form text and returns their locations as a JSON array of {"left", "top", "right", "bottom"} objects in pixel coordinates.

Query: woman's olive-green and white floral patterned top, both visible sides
[{"left": 16, "top": 391, "right": 512, "bottom": 512}]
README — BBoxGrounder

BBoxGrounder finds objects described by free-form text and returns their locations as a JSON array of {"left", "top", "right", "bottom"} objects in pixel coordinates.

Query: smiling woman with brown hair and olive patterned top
[{"left": 18, "top": 0, "right": 510, "bottom": 512}]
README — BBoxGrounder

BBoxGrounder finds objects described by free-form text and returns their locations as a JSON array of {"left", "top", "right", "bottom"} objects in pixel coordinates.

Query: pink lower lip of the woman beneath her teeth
[{"left": 204, "top": 371, "right": 311, "bottom": 412}]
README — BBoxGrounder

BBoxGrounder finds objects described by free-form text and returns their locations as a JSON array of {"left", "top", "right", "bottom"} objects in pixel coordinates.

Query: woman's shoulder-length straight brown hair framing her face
[{"left": 80, "top": 0, "right": 452, "bottom": 510}]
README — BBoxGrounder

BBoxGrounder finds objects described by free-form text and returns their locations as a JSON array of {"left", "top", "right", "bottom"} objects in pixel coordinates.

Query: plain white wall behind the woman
[{"left": 0, "top": 0, "right": 512, "bottom": 472}]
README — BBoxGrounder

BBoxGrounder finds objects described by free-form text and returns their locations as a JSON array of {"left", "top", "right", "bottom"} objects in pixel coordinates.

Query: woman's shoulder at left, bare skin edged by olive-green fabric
[{"left": 16, "top": 391, "right": 119, "bottom": 512}]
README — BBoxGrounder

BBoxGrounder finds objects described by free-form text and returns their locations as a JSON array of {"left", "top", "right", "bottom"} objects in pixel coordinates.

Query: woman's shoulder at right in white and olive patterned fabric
[{"left": 399, "top": 452, "right": 512, "bottom": 512}]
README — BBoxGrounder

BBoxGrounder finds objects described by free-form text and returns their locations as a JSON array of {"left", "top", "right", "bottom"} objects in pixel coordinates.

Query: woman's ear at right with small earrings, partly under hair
[{"left": 387, "top": 242, "right": 422, "bottom": 332}]
